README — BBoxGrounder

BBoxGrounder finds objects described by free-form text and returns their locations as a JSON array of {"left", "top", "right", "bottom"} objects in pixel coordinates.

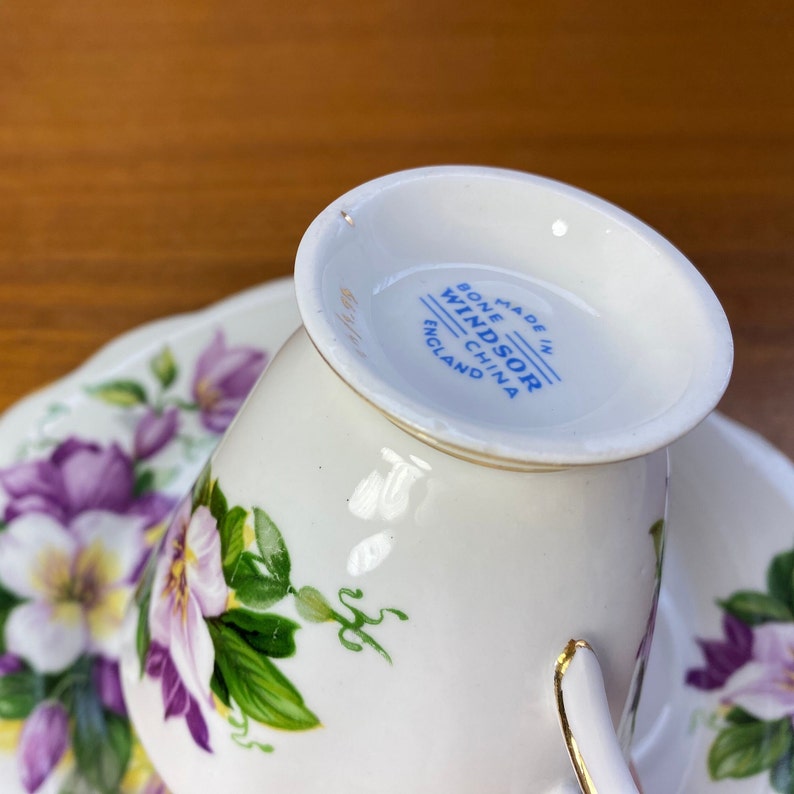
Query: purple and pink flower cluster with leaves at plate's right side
[{"left": 686, "top": 549, "right": 794, "bottom": 794}]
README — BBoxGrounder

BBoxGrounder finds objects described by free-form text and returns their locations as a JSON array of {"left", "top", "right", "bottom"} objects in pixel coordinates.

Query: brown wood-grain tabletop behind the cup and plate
[{"left": 0, "top": 0, "right": 794, "bottom": 455}]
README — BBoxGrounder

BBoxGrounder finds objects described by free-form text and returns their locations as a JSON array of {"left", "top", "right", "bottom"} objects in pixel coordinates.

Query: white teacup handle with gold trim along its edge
[{"left": 554, "top": 640, "right": 639, "bottom": 794}]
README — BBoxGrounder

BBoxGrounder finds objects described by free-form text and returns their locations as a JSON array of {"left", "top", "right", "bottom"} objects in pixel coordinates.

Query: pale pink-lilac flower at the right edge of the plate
[{"left": 723, "top": 623, "right": 794, "bottom": 720}]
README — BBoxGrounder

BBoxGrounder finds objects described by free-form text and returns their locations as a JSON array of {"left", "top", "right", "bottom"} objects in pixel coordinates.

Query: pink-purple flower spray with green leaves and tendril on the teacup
[{"left": 132, "top": 468, "right": 408, "bottom": 752}]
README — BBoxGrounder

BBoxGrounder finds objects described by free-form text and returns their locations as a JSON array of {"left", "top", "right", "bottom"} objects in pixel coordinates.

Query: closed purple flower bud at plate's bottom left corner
[{"left": 17, "top": 701, "right": 69, "bottom": 793}]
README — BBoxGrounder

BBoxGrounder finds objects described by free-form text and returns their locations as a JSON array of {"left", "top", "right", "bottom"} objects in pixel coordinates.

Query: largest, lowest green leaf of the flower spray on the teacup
[{"left": 207, "top": 621, "right": 319, "bottom": 731}]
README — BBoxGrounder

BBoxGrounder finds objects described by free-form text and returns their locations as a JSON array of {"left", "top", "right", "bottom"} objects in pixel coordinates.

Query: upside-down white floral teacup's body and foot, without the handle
[{"left": 123, "top": 167, "right": 732, "bottom": 794}]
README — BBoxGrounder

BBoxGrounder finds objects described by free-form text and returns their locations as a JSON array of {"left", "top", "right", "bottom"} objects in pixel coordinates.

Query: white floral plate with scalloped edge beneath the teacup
[{"left": 0, "top": 279, "right": 794, "bottom": 794}]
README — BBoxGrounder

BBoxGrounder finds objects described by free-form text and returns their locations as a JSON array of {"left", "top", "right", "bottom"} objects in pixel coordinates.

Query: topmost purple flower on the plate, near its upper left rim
[{"left": 193, "top": 331, "right": 267, "bottom": 433}]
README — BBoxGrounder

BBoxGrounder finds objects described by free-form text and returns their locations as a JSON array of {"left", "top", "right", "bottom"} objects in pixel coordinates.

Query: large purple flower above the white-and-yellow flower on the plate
[{"left": 0, "top": 438, "right": 173, "bottom": 526}]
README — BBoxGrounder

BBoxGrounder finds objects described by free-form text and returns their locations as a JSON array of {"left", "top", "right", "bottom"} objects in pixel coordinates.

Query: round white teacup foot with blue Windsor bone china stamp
[{"left": 295, "top": 167, "right": 732, "bottom": 468}]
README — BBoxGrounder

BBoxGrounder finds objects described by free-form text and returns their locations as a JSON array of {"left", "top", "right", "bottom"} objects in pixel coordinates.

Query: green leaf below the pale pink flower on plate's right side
[{"left": 708, "top": 719, "right": 792, "bottom": 780}]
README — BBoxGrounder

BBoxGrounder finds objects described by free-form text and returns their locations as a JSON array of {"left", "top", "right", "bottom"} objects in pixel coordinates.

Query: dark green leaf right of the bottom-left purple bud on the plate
[{"left": 72, "top": 685, "right": 132, "bottom": 794}]
